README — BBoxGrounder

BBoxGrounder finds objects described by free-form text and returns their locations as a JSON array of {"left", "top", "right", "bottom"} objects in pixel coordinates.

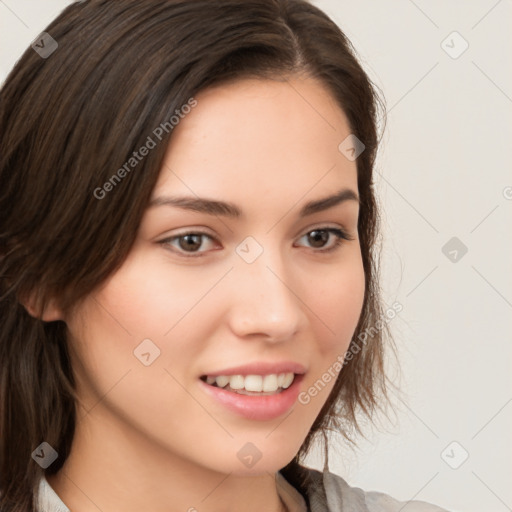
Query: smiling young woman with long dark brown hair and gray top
[{"left": 0, "top": 0, "right": 448, "bottom": 512}]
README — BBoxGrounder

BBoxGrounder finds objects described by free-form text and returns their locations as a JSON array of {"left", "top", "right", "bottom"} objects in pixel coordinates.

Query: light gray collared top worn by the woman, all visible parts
[{"left": 36, "top": 468, "right": 448, "bottom": 512}]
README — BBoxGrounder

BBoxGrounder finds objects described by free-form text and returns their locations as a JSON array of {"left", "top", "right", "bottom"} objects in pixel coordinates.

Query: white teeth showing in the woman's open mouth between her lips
[{"left": 200, "top": 372, "right": 299, "bottom": 396}]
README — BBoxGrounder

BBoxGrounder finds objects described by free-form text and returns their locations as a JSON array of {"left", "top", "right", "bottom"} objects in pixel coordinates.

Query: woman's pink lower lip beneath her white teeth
[{"left": 199, "top": 375, "right": 304, "bottom": 421}]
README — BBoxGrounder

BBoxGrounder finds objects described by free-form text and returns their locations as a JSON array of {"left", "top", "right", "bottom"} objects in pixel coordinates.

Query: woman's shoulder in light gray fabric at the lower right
[{"left": 298, "top": 468, "right": 448, "bottom": 512}]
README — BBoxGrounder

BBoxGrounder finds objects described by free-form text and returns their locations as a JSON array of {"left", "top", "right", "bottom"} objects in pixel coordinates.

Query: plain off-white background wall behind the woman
[{"left": 0, "top": 0, "right": 512, "bottom": 512}]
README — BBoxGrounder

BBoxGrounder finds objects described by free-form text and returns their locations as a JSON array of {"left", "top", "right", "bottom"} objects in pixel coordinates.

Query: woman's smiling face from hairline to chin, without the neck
[{"left": 65, "top": 77, "right": 365, "bottom": 474}]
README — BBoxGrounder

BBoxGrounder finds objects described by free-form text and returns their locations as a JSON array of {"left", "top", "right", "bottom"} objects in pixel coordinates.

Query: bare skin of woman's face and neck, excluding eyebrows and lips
[{"left": 44, "top": 76, "right": 365, "bottom": 512}]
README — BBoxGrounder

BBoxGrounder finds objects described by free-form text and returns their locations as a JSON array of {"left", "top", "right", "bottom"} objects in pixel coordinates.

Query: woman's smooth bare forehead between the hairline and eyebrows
[{"left": 154, "top": 73, "right": 357, "bottom": 208}]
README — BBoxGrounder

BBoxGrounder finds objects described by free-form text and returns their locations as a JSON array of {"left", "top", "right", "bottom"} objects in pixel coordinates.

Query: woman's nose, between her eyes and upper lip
[{"left": 229, "top": 246, "right": 306, "bottom": 342}]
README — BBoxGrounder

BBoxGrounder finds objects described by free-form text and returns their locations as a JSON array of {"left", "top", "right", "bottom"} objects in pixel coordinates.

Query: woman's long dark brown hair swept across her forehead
[{"left": 0, "top": 0, "right": 387, "bottom": 512}]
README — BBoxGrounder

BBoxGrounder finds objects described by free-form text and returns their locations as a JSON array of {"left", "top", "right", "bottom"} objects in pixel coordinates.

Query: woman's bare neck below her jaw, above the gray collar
[{"left": 47, "top": 407, "right": 288, "bottom": 512}]
